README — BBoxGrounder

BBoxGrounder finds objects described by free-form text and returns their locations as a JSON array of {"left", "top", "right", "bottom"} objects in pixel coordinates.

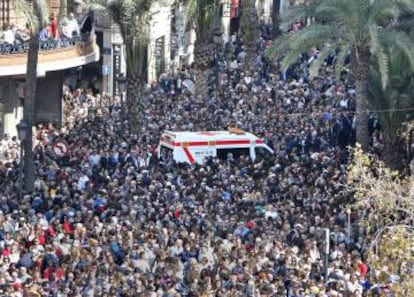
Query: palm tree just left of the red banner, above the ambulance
[{"left": 184, "top": 0, "right": 219, "bottom": 102}]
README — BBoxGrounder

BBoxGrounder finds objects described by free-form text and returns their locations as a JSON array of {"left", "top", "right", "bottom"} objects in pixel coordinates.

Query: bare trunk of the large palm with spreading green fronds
[{"left": 352, "top": 50, "right": 370, "bottom": 151}]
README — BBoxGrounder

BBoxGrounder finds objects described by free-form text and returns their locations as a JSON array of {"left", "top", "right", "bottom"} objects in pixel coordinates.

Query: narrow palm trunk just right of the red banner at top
[{"left": 240, "top": 0, "right": 260, "bottom": 70}]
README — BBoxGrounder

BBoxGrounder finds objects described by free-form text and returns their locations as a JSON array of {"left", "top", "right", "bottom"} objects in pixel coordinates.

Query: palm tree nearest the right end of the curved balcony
[{"left": 106, "top": 0, "right": 154, "bottom": 133}]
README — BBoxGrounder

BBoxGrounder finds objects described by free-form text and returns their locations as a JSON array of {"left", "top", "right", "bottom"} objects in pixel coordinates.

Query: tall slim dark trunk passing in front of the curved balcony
[{"left": 23, "top": 0, "right": 42, "bottom": 193}]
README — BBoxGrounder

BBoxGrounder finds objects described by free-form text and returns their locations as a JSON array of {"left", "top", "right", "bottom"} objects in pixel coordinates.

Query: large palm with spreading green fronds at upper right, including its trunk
[{"left": 268, "top": 0, "right": 414, "bottom": 149}]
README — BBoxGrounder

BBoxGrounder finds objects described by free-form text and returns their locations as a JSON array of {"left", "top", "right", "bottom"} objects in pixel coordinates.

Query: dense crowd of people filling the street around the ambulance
[{"left": 0, "top": 24, "right": 413, "bottom": 297}]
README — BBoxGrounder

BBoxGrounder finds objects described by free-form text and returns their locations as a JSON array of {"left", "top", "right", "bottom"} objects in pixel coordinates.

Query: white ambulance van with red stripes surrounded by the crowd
[{"left": 157, "top": 128, "right": 274, "bottom": 164}]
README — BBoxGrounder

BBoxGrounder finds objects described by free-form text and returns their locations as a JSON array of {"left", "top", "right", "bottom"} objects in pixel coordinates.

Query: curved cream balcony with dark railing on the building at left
[{"left": 0, "top": 33, "right": 99, "bottom": 77}]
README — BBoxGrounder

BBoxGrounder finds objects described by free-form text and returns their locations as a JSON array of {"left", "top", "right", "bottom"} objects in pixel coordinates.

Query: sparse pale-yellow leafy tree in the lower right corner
[{"left": 346, "top": 146, "right": 414, "bottom": 296}]
